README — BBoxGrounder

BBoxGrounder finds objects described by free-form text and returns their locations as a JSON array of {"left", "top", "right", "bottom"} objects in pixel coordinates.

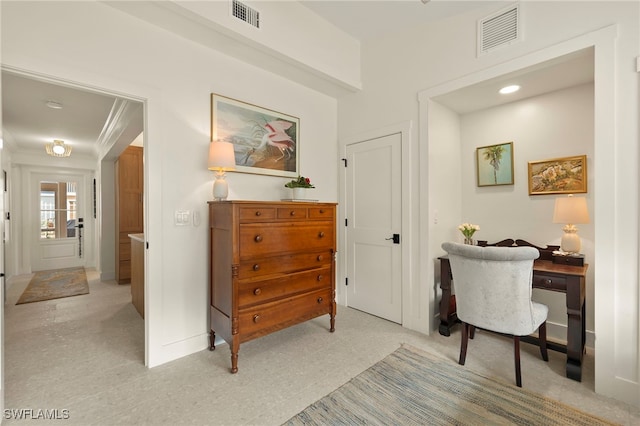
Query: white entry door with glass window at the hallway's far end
[{"left": 31, "top": 176, "right": 84, "bottom": 271}]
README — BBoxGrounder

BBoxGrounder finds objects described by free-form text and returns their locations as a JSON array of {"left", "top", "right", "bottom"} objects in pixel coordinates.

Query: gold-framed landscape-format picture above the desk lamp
[{"left": 528, "top": 155, "right": 587, "bottom": 195}]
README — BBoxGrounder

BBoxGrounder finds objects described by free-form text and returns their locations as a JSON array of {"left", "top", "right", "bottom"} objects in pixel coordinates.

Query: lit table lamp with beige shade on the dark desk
[{"left": 553, "top": 194, "right": 589, "bottom": 254}]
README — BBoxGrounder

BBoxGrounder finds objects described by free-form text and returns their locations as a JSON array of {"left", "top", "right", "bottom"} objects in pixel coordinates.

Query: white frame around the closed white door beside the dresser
[{"left": 336, "top": 121, "right": 412, "bottom": 330}]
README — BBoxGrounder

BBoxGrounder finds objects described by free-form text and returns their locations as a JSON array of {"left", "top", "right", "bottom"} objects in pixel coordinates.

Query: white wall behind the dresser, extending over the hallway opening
[{"left": 2, "top": 2, "right": 337, "bottom": 366}]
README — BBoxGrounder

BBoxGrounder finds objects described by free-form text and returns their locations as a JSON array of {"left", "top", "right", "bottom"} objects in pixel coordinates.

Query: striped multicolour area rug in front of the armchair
[{"left": 285, "top": 345, "right": 613, "bottom": 426}]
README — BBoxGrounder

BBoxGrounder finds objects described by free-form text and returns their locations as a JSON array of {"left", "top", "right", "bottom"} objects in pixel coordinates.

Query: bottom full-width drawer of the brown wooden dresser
[{"left": 238, "top": 289, "right": 332, "bottom": 342}]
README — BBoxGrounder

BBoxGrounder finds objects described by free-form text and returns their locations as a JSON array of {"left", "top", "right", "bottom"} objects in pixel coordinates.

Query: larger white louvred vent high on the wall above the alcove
[{"left": 478, "top": 5, "right": 520, "bottom": 56}]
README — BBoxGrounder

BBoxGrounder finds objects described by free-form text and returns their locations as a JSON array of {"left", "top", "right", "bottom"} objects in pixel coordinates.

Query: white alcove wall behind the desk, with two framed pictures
[{"left": 456, "top": 84, "right": 596, "bottom": 347}]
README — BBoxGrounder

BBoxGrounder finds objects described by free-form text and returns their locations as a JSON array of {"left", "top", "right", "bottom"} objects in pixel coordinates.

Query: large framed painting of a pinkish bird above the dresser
[{"left": 211, "top": 93, "right": 300, "bottom": 178}]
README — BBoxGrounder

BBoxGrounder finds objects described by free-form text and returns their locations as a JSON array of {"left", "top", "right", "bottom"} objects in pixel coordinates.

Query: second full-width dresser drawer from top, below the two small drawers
[{"left": 238, "top": 249, "right": 333, "bottom": 280}]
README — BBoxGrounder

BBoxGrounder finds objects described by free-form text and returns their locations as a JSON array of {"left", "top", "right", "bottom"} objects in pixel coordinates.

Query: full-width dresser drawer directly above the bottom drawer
[{"left": 238, "top": 267, "right": 332, "bottom": 309}]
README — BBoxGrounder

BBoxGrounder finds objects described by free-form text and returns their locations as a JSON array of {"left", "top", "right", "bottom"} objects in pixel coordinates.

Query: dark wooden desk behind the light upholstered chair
[{"left": 438, "top": 256, "right": 589, "bottom": 381}]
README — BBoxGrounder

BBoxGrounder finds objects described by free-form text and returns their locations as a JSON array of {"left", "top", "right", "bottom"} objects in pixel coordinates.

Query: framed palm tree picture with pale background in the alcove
[{"left": 476, "top": 142, "right": 513, "bottom": 186}]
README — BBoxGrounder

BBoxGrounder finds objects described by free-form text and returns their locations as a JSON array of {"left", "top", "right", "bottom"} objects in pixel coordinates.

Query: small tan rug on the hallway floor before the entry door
[{"left": 16, "top": 268, "right": 89, "bottom": 305}]
